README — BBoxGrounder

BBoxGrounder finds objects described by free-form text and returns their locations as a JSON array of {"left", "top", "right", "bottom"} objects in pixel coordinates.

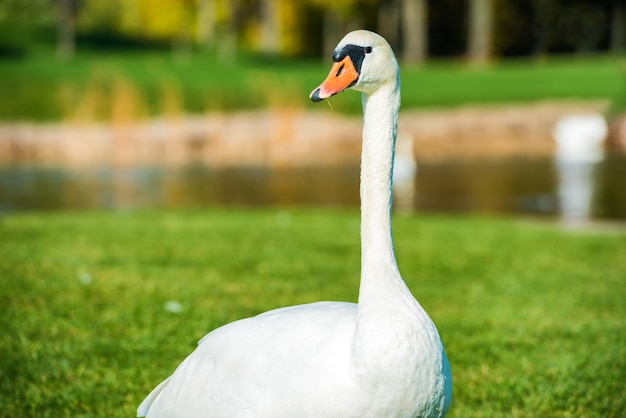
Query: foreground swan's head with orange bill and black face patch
[{"left": 309, "top": 30, "right": 399, "bottom": 102}]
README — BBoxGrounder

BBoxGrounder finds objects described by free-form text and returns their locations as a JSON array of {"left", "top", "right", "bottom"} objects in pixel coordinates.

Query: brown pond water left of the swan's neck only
[{"left": 0, "top": 165, "right": 359, "bottom": 212}]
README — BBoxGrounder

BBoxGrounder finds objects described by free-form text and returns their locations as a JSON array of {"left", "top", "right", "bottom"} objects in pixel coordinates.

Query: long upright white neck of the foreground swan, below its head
[{"left": 359, "top": 80, "right": 408, "bottom": 306}]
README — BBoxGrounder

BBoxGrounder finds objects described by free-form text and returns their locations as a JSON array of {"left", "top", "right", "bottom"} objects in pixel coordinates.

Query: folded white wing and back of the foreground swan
[{"left": 138, "top": 302, "right": 356, "bottom": 418}]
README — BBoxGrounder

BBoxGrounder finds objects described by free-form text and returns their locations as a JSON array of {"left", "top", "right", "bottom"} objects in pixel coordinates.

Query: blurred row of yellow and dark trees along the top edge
[{"left": 0, "top": 0, "right": 626, "bottom": 63}]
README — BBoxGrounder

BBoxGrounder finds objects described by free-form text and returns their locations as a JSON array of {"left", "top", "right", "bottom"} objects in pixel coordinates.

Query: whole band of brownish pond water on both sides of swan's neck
[{"left": 0, "top": 154, "right": 626, "bottom": 220}]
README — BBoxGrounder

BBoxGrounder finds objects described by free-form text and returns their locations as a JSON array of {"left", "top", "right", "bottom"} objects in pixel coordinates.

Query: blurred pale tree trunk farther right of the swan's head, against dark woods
[{"left": 468, "top": 0, "right": 494, "bottom": 65}]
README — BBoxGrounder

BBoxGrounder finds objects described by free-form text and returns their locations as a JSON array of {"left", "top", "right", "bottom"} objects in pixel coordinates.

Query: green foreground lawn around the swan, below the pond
[{"left": 0, "top": 210, "right": 626, "bottom": 417}]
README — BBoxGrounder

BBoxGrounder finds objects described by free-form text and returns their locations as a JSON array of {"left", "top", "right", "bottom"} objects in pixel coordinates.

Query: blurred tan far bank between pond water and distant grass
[{"left": 0, "top": 101, "right": 626, "bottom": 168}]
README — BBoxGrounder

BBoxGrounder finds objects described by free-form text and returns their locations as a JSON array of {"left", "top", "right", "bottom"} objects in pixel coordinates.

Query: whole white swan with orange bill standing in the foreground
[{"left": 137, "top": 31, "right": 452, "bottom": 418}]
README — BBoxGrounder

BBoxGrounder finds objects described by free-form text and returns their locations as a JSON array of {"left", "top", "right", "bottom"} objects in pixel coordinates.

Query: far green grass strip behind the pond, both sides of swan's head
[{"left": 0, "top": 51, "right": 626, "bottom": 120}]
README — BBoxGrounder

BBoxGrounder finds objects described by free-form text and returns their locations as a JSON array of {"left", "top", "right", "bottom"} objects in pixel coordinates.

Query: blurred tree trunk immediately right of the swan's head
[{"left": 402, "top": 0, "right": 428, "bottom": 64}]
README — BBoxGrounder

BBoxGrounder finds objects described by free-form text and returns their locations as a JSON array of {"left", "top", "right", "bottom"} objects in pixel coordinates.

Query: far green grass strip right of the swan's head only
[{"left": 402, "top": 56, "right": 626, "bottom": 107}]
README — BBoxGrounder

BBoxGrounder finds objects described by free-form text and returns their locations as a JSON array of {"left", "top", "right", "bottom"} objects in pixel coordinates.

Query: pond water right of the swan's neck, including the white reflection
[{"left": 415, "top": 154, "right": 626, "bottom": 222}]
